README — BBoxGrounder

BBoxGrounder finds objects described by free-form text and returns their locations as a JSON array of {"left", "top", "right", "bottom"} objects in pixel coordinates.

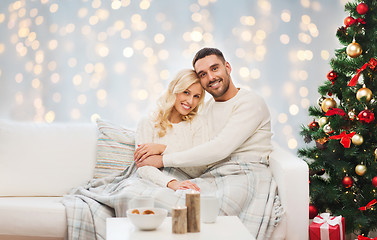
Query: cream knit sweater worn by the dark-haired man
[{"left": 163, "top": 89, "right": 272, "bottom": 167}]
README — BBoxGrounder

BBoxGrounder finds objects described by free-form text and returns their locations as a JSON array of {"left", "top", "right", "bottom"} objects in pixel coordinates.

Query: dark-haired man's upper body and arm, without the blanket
[{"left": 136, "top": 48, "right": 272, "bottom": 168}]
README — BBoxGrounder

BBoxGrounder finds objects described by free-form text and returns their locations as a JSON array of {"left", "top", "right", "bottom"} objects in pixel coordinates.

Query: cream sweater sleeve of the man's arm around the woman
[{"left": 163, "top": 95, "right": 270, "bottom": 167}]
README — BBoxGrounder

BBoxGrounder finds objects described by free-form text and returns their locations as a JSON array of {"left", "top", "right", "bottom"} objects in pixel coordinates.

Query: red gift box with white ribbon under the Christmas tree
[{"left": 309, "top": 213, "right": 345, "bottom": 240}]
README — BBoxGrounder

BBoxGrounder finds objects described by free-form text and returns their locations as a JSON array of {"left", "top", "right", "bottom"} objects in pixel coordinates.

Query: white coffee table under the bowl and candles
[{"left": 106, "top": 216, "right": 255, "bottom": 240}]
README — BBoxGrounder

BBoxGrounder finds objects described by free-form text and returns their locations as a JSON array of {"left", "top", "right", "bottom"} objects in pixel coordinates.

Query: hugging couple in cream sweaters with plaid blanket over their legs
[{"left": 63, "top": 48, "right": 282, "bottom": 239}]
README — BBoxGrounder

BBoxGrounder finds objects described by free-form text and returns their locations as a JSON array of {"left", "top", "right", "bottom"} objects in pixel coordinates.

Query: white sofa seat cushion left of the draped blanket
[{"left": 0, "top": 197, "right": 67, "bottom": 238}]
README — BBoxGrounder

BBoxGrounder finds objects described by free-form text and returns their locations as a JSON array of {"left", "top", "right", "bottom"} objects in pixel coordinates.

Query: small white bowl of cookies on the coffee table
[{"left": 127, "top": 207, "right": 168, "bottom": 231}]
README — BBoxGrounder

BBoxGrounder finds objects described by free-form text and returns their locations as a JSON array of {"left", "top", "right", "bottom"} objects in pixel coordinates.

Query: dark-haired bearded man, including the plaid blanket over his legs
[{"left": 135, "top": 48, "right": 283, "bottom": 240}]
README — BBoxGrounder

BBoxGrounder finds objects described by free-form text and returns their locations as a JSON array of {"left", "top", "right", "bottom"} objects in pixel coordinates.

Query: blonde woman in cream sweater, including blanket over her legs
[{"left": 62, "top": 70, "right": 207, "bottom": 239}]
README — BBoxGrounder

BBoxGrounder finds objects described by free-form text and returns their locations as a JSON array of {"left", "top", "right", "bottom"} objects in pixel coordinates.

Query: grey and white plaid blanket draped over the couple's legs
[{"left": 62, "top": 157, "right": 283, "bottom": 240}]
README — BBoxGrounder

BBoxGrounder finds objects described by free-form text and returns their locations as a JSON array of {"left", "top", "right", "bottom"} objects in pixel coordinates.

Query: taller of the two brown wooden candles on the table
[{"left": 186, "top": 190, "right": 200, "bottom": 232}]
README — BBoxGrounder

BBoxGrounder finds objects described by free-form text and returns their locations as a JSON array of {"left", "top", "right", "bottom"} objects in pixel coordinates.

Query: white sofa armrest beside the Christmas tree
[{"left": 270, "top": 142, "right": 309, "bottom": 240}]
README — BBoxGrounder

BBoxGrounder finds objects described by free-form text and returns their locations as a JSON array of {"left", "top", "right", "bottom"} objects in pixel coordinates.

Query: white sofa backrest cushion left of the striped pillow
[{"left": 0, "top": 120, "right": 97, "bottom": 196}]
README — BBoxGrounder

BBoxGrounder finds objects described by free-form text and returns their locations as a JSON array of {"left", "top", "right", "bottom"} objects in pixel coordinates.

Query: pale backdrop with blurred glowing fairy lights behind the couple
[{"left": 0, "top": 0, "right": 346, "bottom": 151}]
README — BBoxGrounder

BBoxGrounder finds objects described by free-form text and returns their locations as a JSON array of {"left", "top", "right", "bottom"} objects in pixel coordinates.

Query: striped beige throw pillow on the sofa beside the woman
[{"left": 94, "top": 119, "right": 135, "bottom": 178}]
